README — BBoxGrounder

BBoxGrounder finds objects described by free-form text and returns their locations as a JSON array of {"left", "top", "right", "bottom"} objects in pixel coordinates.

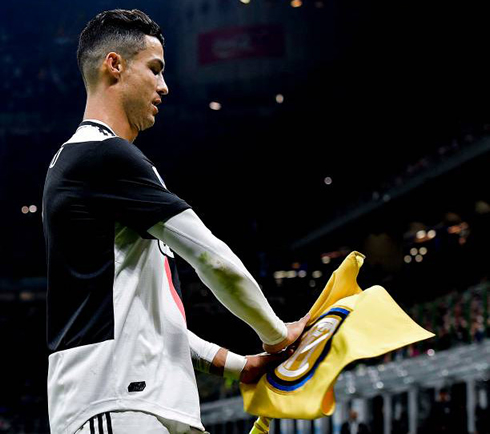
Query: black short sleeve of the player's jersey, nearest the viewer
[{"left": 88, "top": 137, "right": 190, "bottom": 238}]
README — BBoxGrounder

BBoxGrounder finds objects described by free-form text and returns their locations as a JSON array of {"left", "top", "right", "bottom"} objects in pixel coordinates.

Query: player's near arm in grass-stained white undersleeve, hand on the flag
[{"left": 148, "top": 209, "right": 308, "bottom": 352}]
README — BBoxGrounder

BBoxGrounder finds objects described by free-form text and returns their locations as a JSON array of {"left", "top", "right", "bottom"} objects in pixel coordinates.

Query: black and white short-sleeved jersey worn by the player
[{"left": 43, "top": 121, "right": 203, "bottom": 434}]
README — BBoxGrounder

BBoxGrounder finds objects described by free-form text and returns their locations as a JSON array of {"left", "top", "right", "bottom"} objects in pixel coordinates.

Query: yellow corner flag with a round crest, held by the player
[{"left": 240, "top": 252, "right": 434, "bottom": 428}]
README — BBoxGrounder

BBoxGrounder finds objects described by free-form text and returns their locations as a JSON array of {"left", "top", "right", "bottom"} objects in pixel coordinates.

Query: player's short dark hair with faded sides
[{"left": 77, "top": 9, "right": 165, "bottom": 86}]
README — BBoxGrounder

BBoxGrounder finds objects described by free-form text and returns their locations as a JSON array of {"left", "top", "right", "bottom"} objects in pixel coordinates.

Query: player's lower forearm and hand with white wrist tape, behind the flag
[{"left": 187, "top": 330, "right": 289, "bottom": 384}]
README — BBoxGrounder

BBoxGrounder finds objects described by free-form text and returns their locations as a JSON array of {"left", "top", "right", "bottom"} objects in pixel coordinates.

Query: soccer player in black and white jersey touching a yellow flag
[{"left": 43, "top": 10, "right": 308, "bottom": 434}]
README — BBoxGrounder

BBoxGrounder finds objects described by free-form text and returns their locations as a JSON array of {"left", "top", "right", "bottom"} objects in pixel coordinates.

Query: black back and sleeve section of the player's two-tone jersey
[{"left": 43, "top": 131, "right": 189, "bottom": 353}]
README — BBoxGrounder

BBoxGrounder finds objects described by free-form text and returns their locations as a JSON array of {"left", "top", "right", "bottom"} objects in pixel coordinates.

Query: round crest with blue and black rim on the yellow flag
[{"left": 266, "top": 306, "right": 352, "bottom": 392}]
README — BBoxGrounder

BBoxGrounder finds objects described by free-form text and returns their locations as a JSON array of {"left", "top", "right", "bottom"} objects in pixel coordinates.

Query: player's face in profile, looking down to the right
[{"left": 121, "top": 36, "right": 168, "bottom": 131}]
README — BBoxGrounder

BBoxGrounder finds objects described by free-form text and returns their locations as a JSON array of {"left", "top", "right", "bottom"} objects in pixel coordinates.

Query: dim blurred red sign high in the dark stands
[{"left": 199, "top": 25, "right": 284, "bottom": 65}]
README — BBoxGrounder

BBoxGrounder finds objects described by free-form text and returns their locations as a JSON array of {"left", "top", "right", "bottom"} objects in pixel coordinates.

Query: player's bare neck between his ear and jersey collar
[{"left": 83, "top": 89, "right": 138, "bottom": 143}]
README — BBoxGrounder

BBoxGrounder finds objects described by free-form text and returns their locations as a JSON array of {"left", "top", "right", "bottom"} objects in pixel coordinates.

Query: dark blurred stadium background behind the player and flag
[{"left": 0, "top": 0, "right": 490, "bottom": 434}]
